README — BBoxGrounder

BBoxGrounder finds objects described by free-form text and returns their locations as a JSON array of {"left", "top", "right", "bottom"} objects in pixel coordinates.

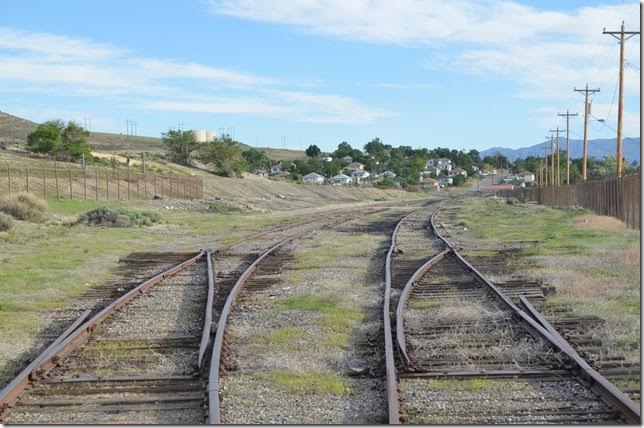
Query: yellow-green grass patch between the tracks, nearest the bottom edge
[{"left": 261, "top": 371, "right": 353, "bottom": 395}]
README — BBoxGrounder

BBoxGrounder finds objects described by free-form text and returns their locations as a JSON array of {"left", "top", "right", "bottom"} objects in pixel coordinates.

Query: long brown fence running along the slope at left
[{"left": 0, "top": 164, "right": 203, "bottom": 201}]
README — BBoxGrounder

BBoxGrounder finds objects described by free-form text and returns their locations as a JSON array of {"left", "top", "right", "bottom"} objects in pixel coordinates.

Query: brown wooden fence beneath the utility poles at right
[{"left": 498, "top": 175, "right": 641, "bottom": 229}]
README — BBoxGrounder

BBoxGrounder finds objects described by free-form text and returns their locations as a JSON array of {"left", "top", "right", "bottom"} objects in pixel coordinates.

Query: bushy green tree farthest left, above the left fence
[{"left": 27, "top": 120, "right": 91, "bottom": 161}]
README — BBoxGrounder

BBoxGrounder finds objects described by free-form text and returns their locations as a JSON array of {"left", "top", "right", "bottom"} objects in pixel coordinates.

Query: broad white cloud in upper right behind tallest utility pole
[{"left": 209, "top": 0, "right": 639, "bottom": 108}]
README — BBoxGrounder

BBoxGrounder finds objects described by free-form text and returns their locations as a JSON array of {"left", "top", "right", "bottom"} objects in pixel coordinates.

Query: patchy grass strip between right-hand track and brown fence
[{"left": 456, "top": 198, "right": 640, "bottom": 361}]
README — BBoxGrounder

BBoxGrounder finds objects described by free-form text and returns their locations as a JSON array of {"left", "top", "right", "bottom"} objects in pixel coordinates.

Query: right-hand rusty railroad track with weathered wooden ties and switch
[{"left": 384, "top": 204, "right": 640, "bottom": 424}]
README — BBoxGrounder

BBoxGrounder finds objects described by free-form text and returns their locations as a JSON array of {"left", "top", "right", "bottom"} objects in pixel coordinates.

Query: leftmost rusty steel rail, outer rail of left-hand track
[{"left": 0, "top": 251, "right": 204, "bottom": 412}]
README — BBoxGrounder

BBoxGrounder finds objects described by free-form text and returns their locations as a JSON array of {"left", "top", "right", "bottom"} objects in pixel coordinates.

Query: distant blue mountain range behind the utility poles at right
[{"left": 481, "top": 137, "right": 640, "bottom": 164}]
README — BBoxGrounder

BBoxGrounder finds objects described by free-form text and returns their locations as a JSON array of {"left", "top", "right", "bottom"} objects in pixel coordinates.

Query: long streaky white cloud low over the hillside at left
[{"left": 0, "top": 27, "right": 386, "bottom": 123}]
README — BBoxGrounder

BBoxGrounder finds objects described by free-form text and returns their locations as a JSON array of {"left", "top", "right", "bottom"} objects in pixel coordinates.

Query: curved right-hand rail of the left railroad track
[{"left": 208, "top": 230, "right": 310, "bottom": 425}]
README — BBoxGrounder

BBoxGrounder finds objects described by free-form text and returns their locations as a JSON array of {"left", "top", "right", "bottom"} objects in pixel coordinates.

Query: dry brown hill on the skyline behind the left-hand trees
[{"left": 0, "top": 112, "right": 306, "bottom": 160}]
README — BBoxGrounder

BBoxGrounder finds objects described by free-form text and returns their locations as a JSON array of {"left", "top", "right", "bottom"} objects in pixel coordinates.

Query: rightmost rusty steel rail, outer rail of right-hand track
[{"left": 431, "top": 207, "right": 641, "bottom": 424}]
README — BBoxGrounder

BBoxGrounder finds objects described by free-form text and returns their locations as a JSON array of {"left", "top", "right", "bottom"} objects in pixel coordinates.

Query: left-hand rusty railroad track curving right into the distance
[{"left": 0, "top": 202, "right": 412, "bottom": 424}]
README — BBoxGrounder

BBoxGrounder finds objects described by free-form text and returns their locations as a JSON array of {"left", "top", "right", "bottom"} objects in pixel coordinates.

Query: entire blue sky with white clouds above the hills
[{"left": 0, "top": 0, "right": 640, "bottom": 154}]
